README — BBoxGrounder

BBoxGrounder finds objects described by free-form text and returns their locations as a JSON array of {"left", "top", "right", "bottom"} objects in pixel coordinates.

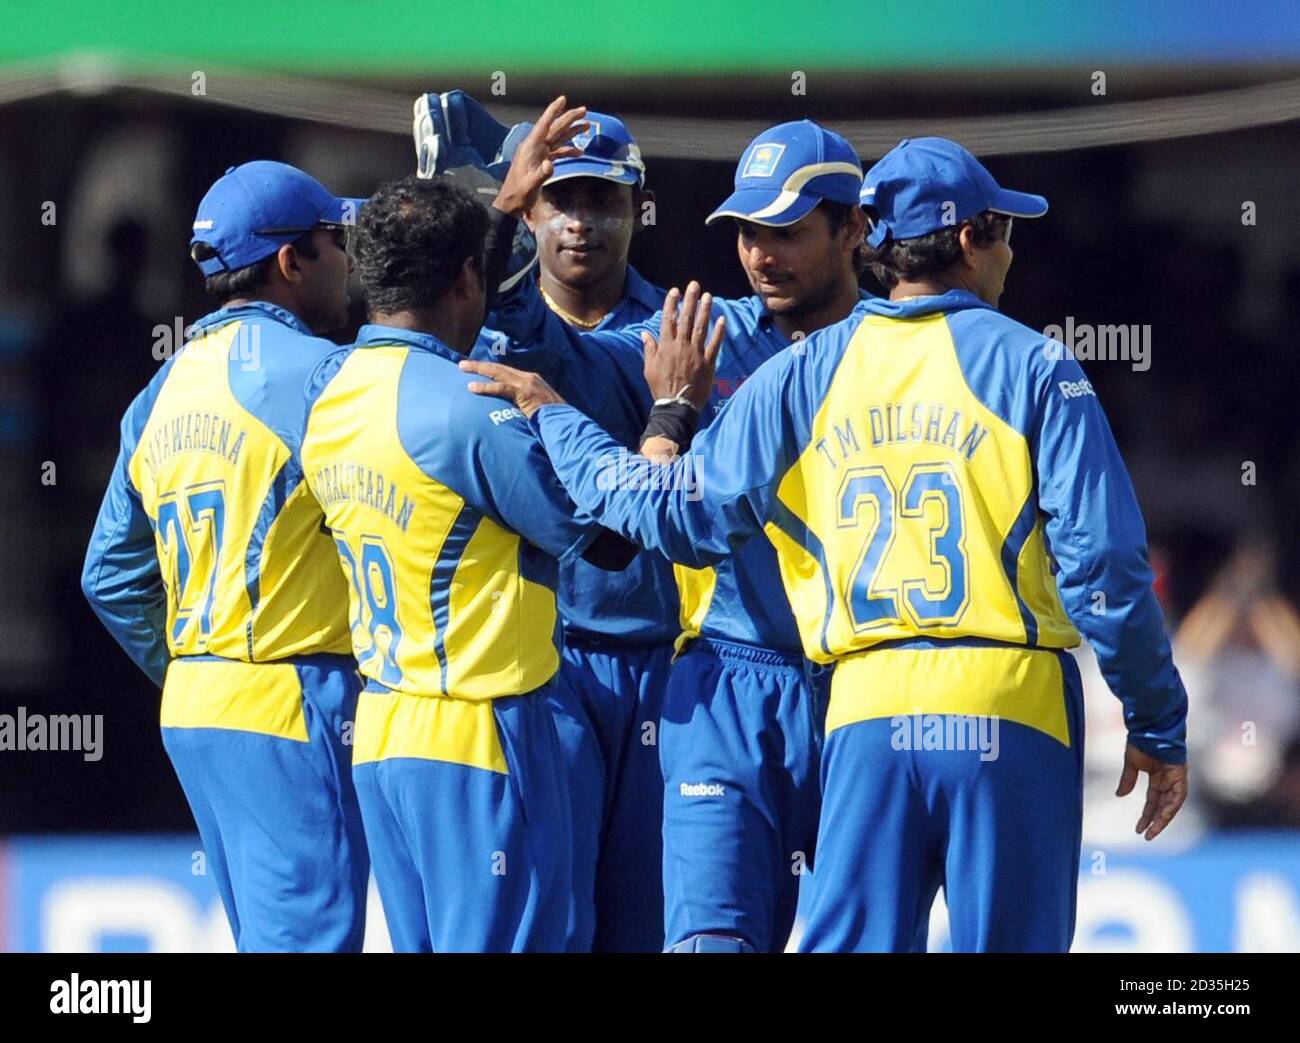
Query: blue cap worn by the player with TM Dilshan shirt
[{"left": 862, "top": 138, "right": 1048, "bottom": 246}]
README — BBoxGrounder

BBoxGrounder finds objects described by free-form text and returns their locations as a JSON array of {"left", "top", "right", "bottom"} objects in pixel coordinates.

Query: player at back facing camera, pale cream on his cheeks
[{"left": 434, "top": 99, "right": 679, "bottom": 952}]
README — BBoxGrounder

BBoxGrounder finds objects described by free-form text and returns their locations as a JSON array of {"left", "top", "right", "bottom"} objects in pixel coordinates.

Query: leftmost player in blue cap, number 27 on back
[{"left": 82, "top": 161, "right": 369, "bottom": 952}]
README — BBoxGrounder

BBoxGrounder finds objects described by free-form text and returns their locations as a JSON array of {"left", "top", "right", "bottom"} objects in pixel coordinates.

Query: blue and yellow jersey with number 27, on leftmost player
[{"left": 82, "top": 303, "right": 350, "bottom": 685}]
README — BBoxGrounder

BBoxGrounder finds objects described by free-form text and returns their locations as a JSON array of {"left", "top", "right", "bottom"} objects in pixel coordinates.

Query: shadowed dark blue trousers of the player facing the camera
[{"left": 551, "top": 636, "right": 672, "bottom": 952}]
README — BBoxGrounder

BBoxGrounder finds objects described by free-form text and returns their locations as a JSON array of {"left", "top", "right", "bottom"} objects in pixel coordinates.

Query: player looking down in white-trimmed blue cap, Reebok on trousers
[{"left": 462, "top": 120, "right": 866, "bottom": 952}]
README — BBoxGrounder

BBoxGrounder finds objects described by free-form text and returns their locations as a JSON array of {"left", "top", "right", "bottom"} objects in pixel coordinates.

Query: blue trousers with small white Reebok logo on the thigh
[{"left": 660, "top": 639, "right": 824, "bottom": 952}]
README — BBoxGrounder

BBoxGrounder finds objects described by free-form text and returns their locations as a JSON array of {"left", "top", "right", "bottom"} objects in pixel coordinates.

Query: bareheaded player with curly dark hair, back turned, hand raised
[{"left": 303, "top": 101, "right": 634, "bottom": 952}]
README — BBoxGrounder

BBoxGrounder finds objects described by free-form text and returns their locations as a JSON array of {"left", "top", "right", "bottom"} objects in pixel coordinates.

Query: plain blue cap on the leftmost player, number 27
[{"left": 190, "top": 160, "right": 365, "bottom": 276}]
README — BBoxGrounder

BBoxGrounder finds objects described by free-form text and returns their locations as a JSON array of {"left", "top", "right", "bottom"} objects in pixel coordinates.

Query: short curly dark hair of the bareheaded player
[{"left": 356, "top": 177, "right": 488, "bottom": 313}]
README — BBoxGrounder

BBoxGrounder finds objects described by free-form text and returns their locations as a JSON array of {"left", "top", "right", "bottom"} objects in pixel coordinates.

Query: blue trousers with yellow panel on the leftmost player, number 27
[{"left": 163, "top": 655, "right": 369, "bottom": 952}]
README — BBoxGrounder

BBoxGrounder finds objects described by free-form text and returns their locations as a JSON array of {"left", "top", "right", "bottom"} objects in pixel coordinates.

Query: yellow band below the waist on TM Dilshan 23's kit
[{"left": 826, "top": 645, "right": 1070, "bottom": 746}]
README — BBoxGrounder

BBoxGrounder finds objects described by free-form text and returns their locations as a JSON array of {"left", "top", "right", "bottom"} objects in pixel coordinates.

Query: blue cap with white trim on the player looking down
[{"left": 705, "top": 120, "right": 862, "bottom": 225}]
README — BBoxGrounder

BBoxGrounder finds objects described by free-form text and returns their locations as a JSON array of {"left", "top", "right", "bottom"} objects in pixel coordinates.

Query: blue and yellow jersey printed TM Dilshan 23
[{"left": 534, "top": 290, "right": 1187, "bottom": 759}]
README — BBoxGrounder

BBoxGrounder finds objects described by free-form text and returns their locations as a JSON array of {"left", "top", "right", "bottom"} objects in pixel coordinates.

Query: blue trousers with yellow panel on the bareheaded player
[{"left": 352, "top": 689, "right": 573, "bottom": 952}]
